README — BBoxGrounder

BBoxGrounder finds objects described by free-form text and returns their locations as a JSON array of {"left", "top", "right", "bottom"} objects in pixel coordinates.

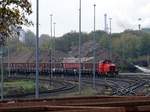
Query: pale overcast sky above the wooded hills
[{"left": 23, "top": 0, "right": 150, "bottom": 36}]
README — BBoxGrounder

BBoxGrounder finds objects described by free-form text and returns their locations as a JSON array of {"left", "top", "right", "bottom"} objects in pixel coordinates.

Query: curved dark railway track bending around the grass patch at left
[{"left": 5, "top": 76, "right": 77, "bottom": 98}]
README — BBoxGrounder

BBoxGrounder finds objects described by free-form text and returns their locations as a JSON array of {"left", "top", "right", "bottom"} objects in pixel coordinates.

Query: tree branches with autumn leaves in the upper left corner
[{"left": 0, "top": 0, "right": 32, "bottom": 45}]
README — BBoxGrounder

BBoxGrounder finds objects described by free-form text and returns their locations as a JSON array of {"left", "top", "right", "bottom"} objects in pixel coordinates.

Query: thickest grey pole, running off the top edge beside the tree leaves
[{"left": 35, "top": 0, "right": 39, "bottom": 98}]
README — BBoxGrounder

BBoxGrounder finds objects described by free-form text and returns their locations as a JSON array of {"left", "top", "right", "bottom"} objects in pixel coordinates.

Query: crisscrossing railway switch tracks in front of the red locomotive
[{"left": 79, "top": 77, "right": 149, "bottom": 96}]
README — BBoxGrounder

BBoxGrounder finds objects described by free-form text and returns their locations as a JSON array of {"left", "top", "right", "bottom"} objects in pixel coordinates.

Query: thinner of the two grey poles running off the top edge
[{"left": 79, "top": 0, "right": 81, "bottom": 94}]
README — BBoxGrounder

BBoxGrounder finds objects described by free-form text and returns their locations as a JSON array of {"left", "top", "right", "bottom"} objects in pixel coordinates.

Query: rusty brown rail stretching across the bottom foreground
[{"left": 0, "top": 96, "right": 150, "bottom": 112}]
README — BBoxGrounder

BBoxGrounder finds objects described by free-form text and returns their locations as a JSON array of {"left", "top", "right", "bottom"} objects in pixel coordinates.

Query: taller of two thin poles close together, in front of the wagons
[{"left": 49, "top": 14, "right": 53, "bottom": 82}]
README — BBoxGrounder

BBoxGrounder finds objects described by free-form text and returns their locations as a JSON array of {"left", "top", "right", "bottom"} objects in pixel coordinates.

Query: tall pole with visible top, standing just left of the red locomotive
[{"left": 93, "top": 4, "right": 96, "bottom": 89}]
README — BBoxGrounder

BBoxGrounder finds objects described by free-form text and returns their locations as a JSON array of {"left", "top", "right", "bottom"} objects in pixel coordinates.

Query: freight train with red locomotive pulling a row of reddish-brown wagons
[{"left": 4, "top": 60, "right": 118, "bottom": 75}]
